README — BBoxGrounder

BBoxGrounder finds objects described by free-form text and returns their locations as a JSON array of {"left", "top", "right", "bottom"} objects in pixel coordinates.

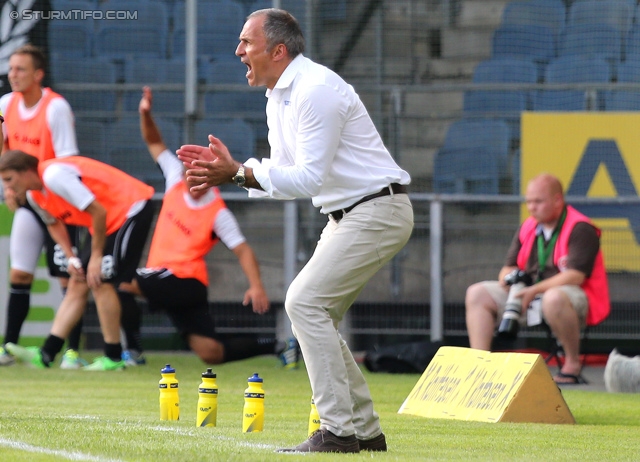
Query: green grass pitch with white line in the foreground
[{"left": 0, "top": 353, "right": 640, "bottom": 462}]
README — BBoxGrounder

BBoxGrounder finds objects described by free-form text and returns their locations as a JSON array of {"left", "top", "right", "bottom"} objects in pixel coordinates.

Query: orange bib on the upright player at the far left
[{"left": 4, "top": 88, "right": 62, "bottom": 161}]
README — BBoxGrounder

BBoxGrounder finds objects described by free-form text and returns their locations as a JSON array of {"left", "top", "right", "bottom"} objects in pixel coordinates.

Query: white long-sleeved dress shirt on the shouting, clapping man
[{"left": 245, "top": 55, "right": 411, "bottom": 213}]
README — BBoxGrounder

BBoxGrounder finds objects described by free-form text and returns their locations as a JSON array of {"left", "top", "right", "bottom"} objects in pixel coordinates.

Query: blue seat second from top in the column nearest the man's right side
[{"left": 492, "top": 24, "right": 557, "bottom": 67}]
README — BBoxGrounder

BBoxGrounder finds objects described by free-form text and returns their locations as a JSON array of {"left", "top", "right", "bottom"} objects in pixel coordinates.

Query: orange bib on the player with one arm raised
[{"left": 147, "top": 181, "right": 226, "bottom": 285}]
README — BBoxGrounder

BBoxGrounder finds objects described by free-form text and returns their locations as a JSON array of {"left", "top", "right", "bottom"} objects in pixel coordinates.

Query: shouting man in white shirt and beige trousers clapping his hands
[{"left": 178, "top": 9, "right": 413, "bottom": 453}]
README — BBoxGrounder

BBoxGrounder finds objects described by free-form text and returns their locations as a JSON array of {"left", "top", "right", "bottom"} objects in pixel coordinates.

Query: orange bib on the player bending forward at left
[{"left": 31, "top": 156, "right": 153, "bottom": 235}]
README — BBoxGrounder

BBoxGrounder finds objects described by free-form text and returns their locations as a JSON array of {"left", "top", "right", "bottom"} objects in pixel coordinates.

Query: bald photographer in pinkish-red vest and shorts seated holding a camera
[{"left": 465, "top": 173, "right": 610, "bottom": 384}]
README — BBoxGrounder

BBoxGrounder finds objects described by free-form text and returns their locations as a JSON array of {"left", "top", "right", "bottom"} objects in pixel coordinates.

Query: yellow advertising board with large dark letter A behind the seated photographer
[{"left": 520, "top": 112, "right": 640, "bottom": 272}]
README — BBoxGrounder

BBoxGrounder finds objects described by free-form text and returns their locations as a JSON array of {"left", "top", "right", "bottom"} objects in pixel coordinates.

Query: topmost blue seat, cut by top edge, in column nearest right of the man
[{"left": 502, "top": 0, "right": 567, "bottom": 39}]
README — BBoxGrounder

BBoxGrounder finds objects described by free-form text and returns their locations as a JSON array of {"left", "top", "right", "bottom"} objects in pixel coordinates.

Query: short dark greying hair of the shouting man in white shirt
[{"left": 247, "top": 8, "right": 305, "bottom": 58}]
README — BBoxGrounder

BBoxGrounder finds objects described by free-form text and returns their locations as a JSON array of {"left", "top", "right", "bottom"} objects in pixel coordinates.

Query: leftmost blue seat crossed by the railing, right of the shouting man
[{"left": 463, "top": 57, "right": 538, "bottom": 142}]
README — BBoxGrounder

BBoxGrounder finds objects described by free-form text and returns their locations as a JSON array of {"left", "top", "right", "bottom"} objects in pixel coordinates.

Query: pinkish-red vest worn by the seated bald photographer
[{"left": 517, "top": 205, "right": 611, "bottom": 326}]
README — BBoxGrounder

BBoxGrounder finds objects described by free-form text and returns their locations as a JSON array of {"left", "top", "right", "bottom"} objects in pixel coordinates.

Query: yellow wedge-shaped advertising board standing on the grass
[{"left": 398, "top": 347, "right": 575, "bottom": 424}]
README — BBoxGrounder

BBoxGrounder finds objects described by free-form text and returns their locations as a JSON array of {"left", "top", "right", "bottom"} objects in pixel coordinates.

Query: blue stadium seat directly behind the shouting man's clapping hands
[{"left": 194, "top": 117, "right": 256, "bottom": 160}]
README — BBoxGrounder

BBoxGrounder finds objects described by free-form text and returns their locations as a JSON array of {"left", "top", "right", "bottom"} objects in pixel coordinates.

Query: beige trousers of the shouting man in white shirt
[{"left": 285, "top": 194, "right": 413, "bottom": 439}]
